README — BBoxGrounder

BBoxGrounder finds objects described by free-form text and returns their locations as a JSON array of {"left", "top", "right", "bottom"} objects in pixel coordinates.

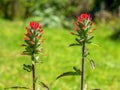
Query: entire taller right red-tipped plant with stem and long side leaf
[{"left": 57, "top": 13, "right": 95, "bottom": 90}]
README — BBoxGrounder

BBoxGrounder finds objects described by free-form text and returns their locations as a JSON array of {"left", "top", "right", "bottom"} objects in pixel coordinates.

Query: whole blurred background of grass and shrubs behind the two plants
[{"left": 0, "top": 0, "right": 120, "bottom": 90}]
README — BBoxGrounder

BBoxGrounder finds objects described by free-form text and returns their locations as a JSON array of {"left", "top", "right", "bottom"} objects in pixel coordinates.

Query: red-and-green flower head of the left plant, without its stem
[{"left": 21, "top": 22, "right": 43, "bottom": 55}]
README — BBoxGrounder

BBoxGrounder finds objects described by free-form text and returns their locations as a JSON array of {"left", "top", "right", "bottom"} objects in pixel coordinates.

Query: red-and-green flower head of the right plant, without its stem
[{"left": 70, "top": 13, "right": 95, "bottom": 43}]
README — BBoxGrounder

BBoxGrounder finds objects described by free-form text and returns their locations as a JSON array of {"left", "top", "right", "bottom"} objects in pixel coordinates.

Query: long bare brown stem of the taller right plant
[{"left": 81, "top": 41, "right": 85, "bottom": 90}]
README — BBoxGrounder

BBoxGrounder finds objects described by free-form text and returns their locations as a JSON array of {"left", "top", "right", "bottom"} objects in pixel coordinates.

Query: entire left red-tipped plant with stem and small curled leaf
[{"left": 21, "top": 22, "right": 43, "bottom": 90}]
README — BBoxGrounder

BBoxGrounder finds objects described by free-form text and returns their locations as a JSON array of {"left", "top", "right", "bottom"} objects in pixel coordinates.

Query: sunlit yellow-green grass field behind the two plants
[{"left": 0, "top": 19, "right": 120, "bottom": 90}]
